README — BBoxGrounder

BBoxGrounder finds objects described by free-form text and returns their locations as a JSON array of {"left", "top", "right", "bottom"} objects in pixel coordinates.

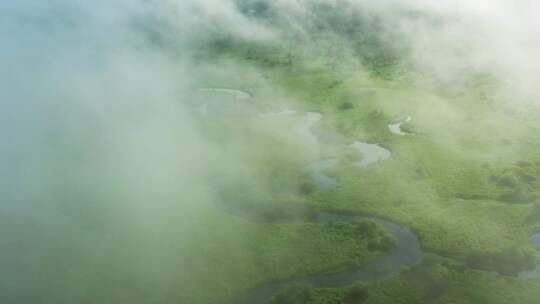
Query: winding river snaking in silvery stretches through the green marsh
[{"left": 199, "top": 88, "right": 540, "bottom": 304}]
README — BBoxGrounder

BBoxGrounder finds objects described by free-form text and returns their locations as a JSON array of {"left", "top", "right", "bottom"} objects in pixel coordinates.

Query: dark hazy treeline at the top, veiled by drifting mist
[{"left": 231, "top": 0, "right": 407, "bottom": 74}]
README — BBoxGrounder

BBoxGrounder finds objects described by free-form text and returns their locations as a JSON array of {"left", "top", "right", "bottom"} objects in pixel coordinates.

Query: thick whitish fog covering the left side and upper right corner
[{"left": 0, "top": 0, "right": 540, "bottom": 303}]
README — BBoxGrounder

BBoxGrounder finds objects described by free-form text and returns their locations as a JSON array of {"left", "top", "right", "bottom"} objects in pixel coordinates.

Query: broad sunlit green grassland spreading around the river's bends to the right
[{"left": 181, "top": 32, "right": 540, "bottom": 303}]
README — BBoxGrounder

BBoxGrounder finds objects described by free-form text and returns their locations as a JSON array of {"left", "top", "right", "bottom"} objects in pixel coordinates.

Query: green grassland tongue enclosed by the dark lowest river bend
[{"left": 175, "top": 201, "right": 386, "bottom": 303}]
